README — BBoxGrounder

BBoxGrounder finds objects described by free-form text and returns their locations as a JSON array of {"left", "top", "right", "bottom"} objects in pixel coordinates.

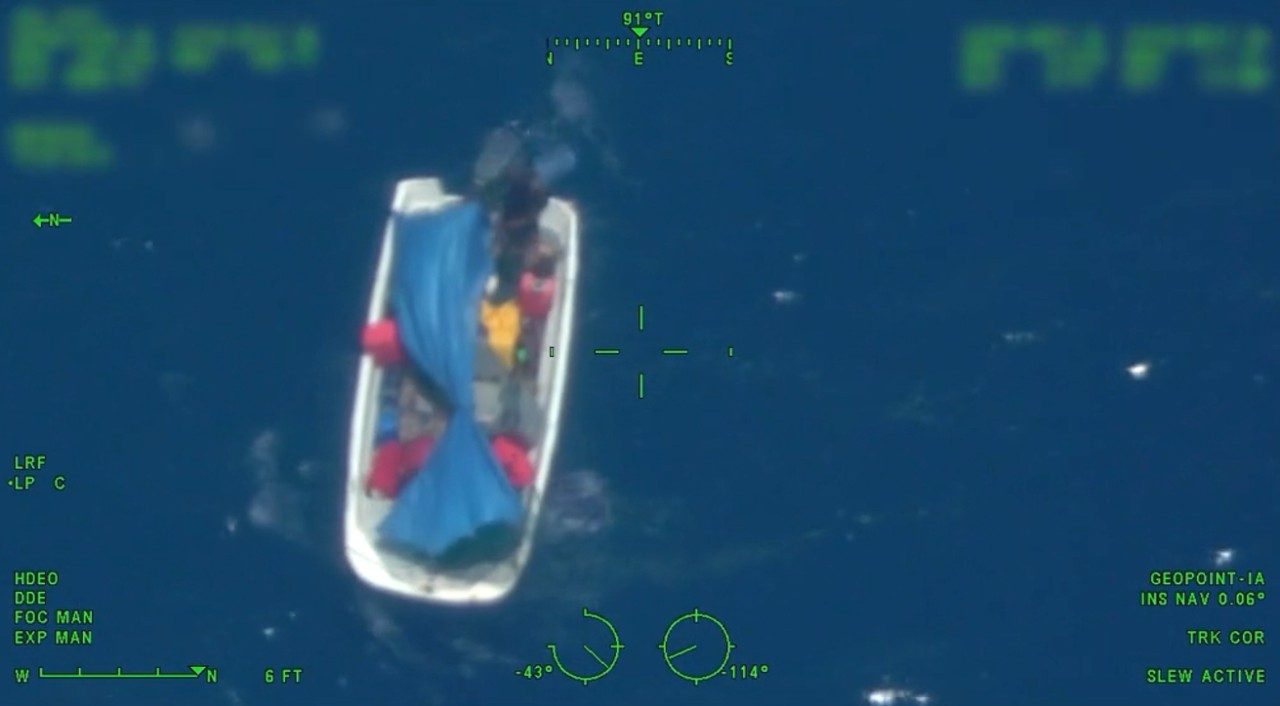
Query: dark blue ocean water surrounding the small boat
[{"left": 0, "top": 3, "right": 1280, "bottom": 706}]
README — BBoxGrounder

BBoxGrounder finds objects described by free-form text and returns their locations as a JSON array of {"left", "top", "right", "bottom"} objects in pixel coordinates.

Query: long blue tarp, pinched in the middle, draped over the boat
[{"left": 378, "top": 202, "right": 521, "bottom": 556}]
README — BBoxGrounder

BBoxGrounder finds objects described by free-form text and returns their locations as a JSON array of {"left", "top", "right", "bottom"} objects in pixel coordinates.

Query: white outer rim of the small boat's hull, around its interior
[{"left": 343, "top": 178, "right": 579, "bottom": 604}]
